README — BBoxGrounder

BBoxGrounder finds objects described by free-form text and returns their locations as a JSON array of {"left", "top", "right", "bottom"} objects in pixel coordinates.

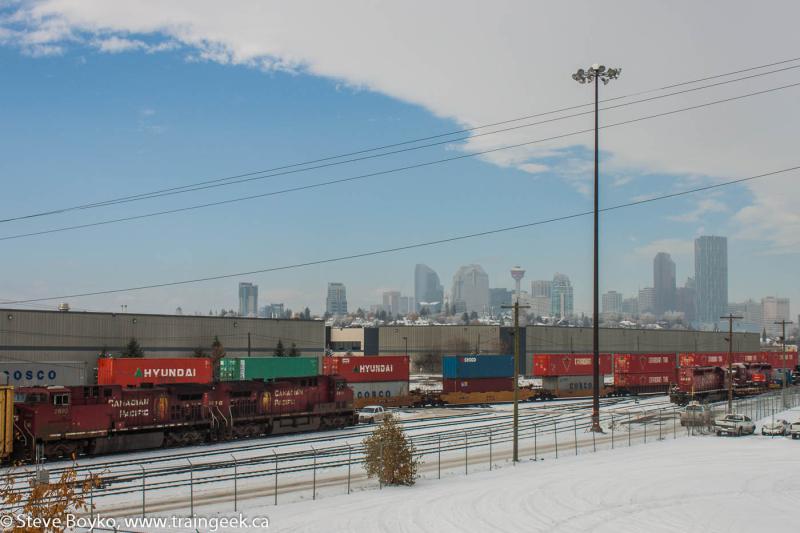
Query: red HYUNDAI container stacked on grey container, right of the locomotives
[{"left": 322, "top": 355, "right": 410, "bottom": 400}]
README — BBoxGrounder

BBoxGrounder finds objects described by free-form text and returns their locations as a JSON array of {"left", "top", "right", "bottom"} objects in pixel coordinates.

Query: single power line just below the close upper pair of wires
[{"left": 6, "top": 82, "right": 800, "bottom": 241}]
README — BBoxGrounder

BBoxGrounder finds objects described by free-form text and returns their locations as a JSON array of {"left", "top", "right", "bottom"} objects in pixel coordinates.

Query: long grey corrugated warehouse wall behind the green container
[{"left": 0, "top": 309, "right": 325, "bottom": 368}]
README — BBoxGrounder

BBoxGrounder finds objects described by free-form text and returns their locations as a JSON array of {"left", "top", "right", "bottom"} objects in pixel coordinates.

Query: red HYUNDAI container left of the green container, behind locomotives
[{"left": 97, "top": 357, "right": 214, "bottom": 387}]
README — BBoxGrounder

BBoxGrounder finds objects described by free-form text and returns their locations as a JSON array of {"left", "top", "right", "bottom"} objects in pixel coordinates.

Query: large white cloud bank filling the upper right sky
[{"left": 0, "top": 0, "right": 800, "bottom": 249}]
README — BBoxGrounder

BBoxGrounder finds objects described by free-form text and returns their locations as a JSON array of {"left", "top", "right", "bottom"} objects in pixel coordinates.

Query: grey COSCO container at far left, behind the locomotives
[{"left": 0, "top": 361, "right": 88, "bottom": 387}]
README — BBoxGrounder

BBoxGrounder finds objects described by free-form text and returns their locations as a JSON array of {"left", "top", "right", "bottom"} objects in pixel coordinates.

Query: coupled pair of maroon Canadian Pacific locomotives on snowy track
[{"left": 13, "top": 376, "right": 356, "bottom": 460}]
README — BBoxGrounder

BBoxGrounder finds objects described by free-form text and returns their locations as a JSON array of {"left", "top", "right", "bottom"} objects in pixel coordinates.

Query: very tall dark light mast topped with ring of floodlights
[{"left": 572, "top": 64, "right": 622, "bottom": 432}]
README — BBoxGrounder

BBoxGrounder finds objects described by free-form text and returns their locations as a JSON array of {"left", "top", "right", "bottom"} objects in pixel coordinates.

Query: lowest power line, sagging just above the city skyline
[{"left": 8, "top": 165, "right": 800, "bottom": 304}]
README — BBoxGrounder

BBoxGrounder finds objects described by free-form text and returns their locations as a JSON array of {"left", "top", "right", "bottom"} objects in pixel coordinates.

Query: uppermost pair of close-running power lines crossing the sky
[{"left": 6, "top": 58, "right": 800, "bottom": 223}]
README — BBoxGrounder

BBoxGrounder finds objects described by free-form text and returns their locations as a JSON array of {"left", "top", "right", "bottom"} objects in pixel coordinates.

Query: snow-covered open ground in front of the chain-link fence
[{"left": 249, "top": 408, "right": 800, "bottom": 533}]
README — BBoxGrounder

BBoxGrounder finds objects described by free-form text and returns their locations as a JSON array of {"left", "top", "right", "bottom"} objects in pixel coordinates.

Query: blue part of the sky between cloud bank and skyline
[{"left": 0, "top": 2, "right": 800, "bottom": 312}]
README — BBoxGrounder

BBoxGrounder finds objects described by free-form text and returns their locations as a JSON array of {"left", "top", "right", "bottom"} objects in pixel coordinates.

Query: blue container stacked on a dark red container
[{"left": 442, "top": 355, "right": 514, "bottom": 393}]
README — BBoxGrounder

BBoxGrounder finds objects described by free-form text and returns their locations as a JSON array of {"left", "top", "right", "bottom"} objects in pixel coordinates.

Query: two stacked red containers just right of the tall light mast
[{"left": 613, "top": 353, "right": 678, "bottom": 393}]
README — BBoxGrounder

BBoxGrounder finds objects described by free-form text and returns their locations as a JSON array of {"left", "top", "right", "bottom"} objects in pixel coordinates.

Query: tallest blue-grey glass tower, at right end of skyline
[{"left": 694, "top": 235, "right": 728, "bottom": 324}]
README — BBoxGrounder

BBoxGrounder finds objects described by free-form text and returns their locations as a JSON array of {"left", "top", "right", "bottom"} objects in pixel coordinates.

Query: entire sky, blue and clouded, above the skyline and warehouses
[{"left": 0, "top": 0, "right": 800, "bottom": 313}]
